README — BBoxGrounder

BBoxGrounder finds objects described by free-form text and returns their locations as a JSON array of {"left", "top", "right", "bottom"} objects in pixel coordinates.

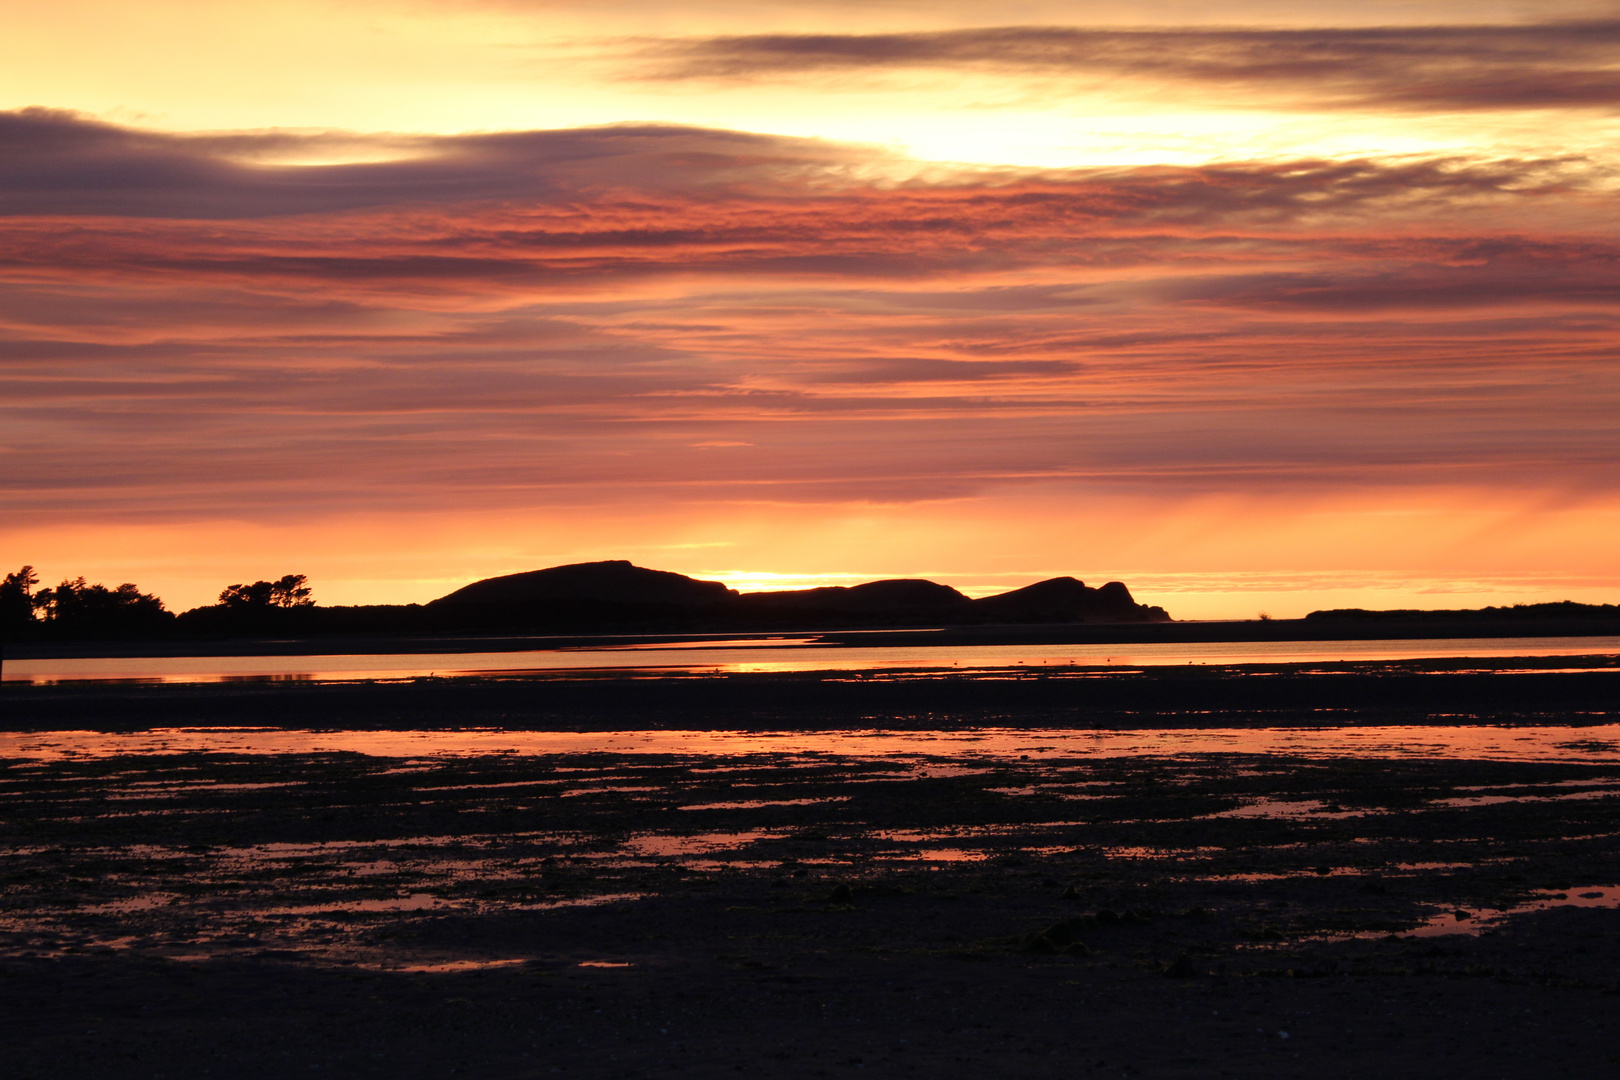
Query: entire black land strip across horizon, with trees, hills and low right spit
[{"left": 0, "top": 559, "right": 1620, "bottom": 656}]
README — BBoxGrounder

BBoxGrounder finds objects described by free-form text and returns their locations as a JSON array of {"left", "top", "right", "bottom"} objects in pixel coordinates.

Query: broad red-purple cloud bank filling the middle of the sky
[{"left": 0, "top": 112, "right": 1620, "bottom": 518}]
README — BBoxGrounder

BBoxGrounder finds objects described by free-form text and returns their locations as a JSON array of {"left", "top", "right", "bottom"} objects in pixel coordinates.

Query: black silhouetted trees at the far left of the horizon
[{"left": 0, "top": 567, "right": 314, "bottom": 641}]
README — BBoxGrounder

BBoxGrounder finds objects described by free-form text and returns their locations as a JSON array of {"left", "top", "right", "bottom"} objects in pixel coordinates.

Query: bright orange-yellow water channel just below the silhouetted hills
[{"left": 3, "top": 636, "right": 1620, "bottom": 683}]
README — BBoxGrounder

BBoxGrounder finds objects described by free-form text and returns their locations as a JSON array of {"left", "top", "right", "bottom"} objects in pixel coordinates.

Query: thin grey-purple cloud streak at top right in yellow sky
[{"left": 637, "top": 19, "right": 1620, "bottom": 110}]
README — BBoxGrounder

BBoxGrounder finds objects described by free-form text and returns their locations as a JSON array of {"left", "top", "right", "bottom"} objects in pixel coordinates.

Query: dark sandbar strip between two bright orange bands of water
[{"left": 0, "top": 657, "right": 1620, "bottom": 730}]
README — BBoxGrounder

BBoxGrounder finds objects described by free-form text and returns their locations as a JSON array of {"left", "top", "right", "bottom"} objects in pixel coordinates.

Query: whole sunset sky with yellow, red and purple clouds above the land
[{"left": 0, "top": 0, "right": 1620, "bottom": 619}]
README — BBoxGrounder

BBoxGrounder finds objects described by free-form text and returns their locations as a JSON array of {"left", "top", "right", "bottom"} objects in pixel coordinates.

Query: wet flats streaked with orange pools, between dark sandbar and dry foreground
[{"left": 0, "top": 725, "right": 1620, "bottom": 973}]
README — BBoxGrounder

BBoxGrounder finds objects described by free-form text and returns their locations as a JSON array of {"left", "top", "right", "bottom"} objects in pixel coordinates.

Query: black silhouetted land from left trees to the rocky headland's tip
[{"left": 0, "top": 559, "right": 1171, "bottom": 641}]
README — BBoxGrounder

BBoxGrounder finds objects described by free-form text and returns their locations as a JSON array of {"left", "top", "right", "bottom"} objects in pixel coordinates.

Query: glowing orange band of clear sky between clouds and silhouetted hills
[{"left": 12, "top": 491, "right": 1620, "bottom": 619}]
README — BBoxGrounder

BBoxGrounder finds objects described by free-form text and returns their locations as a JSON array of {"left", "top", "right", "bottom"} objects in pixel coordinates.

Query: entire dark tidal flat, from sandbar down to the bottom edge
[{"left": 0, "top": 670, "right": 1620, "bottom": 1077}]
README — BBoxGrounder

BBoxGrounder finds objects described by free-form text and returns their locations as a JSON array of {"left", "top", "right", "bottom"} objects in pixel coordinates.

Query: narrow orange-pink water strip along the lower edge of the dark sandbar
[{"left": 0, "top": 724, "right": 1620, "bottom": 761}]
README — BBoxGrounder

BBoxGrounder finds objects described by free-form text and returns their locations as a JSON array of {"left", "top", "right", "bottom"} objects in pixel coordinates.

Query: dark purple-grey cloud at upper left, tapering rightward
[{"left": 0, "top": 108, "right": 870, "bottom": 219}]
